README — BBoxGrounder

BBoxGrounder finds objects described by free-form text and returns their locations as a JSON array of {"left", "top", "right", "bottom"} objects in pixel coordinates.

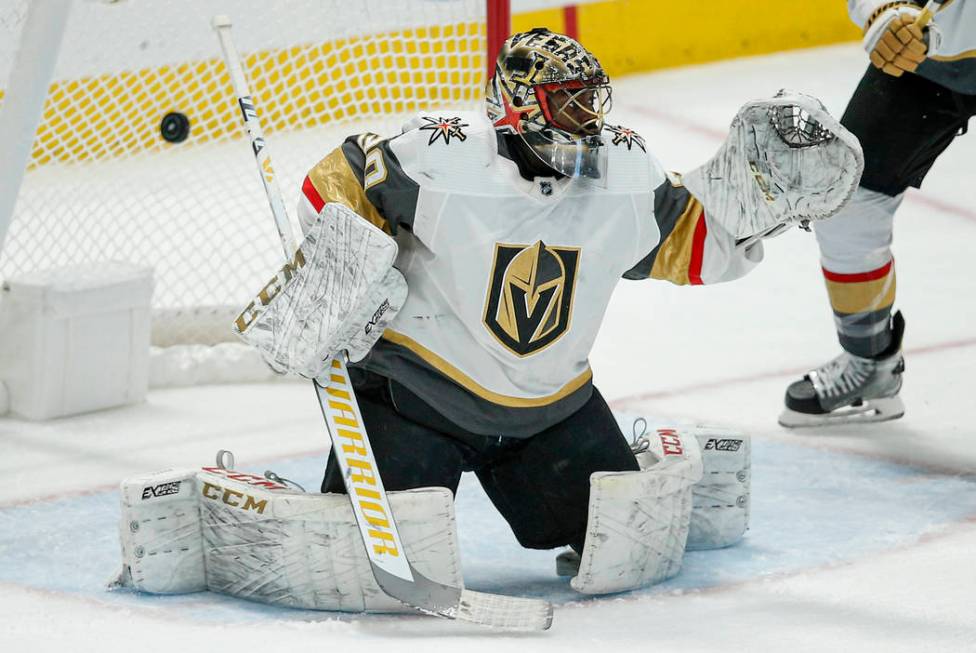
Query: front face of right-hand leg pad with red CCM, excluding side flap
[{"left": 570, "top": 428, "right": 702, "bottom": 594}]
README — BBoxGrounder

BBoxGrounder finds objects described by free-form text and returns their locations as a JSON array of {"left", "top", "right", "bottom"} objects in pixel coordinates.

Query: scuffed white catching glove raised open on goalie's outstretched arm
[{"left": 683, "top": 91, "right": 864, "bottom": 241}]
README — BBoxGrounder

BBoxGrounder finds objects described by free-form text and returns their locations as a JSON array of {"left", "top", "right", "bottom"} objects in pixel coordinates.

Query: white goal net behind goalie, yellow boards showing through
[{"left": 0, "top": 0, "right": 509, "bottom": 346}]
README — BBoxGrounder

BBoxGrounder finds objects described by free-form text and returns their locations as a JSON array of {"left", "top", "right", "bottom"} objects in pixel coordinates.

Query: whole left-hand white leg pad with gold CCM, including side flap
[{"left": 117, "top": 468, "right": 463, "bottom": 613}]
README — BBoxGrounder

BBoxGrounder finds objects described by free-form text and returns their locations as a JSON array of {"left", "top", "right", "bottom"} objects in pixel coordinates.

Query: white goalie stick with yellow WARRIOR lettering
[{"left": 212, "top": 16, "right": 552, "bottom": 630}]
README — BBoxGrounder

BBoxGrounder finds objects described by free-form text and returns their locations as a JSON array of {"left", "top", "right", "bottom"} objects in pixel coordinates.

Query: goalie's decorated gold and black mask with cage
[{"left": 486, "top": 27, "right": 611, "bottom": 180}]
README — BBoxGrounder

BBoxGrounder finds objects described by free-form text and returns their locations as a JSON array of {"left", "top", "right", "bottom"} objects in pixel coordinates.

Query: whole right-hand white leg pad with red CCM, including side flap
[{"left": 568, "top": 417, "right": 751, "bottom": 594}]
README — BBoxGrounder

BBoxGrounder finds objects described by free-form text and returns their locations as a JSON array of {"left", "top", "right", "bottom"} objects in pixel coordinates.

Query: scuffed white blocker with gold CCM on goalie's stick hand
[{"left": 234, "top": 203, "right": 407, "bottom": 378}]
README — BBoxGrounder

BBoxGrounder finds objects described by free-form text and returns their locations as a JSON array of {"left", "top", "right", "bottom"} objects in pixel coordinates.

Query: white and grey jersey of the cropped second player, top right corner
[{"left": 847, "top": 0, "right": 976, "bottom": 95}]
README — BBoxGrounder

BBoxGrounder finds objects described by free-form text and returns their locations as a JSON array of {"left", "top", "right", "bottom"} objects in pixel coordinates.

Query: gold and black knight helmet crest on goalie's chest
[{"left": 483, "top": 240, "right": 580, "bottom": 357}]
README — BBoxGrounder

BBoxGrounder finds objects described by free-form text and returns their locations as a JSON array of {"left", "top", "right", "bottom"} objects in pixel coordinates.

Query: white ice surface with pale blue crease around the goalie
[{"left": 0, "top": 45, "right": 976, "bottom": 653}]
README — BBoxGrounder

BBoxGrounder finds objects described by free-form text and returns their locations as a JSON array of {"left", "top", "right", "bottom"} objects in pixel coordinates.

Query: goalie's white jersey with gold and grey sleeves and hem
[{"left": 300, "top": 113, "right": 762, "bottom": 437}]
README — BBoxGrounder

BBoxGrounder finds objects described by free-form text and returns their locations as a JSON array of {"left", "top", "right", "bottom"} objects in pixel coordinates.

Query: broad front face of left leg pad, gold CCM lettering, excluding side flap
[{"left": 198, "top": 472, "right": 463, "bottom": 613}]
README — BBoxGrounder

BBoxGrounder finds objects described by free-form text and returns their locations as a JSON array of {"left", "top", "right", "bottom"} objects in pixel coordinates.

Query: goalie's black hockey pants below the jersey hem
[{"left": 322, "top": 371, "right": 638, "bottom": 550}]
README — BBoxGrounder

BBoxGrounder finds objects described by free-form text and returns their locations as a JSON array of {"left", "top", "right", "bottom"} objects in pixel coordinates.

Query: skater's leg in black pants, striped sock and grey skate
[{"left": 779, "top": 68, "right": 972, "bottom": 427}]
